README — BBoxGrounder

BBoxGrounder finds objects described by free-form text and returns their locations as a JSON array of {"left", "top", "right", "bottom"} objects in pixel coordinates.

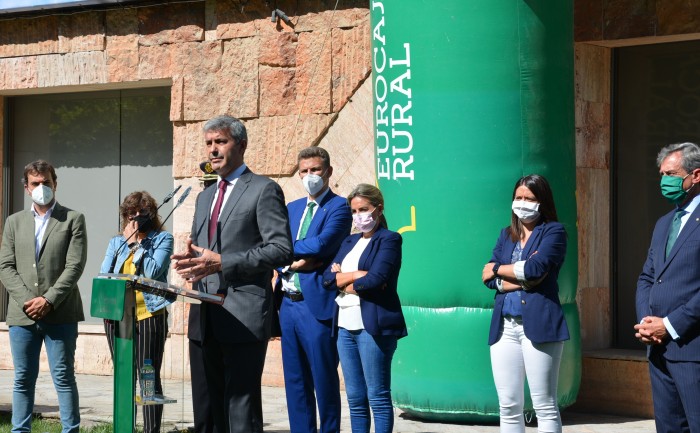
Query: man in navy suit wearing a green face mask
[{"left": 634, "top": 143, "right": 700, "bottom": 433}]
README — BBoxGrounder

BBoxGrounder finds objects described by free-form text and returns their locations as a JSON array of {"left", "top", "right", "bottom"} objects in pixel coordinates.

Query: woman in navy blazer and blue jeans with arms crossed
[{"left": 323, "top": 184, "right": 407, "bottom": 433}]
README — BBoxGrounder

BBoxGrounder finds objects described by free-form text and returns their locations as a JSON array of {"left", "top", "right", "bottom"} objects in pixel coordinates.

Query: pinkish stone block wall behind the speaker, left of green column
[{"left": 0, "top": 0, "right": 374, "bottom": 384}]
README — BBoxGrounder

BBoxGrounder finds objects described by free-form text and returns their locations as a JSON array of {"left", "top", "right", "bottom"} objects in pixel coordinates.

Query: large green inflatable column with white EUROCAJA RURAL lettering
[{"left": 370, "top": 0, "right": 581, "bottom": 421}]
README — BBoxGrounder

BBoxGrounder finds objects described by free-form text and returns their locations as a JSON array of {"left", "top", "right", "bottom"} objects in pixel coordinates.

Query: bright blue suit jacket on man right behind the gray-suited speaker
[{"left": 276, "top": 191, "right": 352, "bottom": 320}]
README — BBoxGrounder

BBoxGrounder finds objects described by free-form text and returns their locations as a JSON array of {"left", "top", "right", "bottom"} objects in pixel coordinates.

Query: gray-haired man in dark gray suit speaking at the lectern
[{"left": 172, "top": 116, "right": 293, "bottom": 433}]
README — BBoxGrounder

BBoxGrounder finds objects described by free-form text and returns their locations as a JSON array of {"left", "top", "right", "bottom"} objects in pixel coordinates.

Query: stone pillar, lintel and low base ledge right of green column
[{"left": 574, "top": 0, "right": 700, "bottom": 417}]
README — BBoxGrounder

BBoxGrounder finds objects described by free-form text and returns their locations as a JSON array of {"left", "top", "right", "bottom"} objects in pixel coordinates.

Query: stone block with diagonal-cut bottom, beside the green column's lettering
[{"left": 331, "top": 21, "right": 372, "bottom": 112}]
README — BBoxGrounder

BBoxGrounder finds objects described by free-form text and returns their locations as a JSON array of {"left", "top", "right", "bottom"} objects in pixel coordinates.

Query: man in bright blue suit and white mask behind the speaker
[{"left": 275, "top": 147, "right": 352, "bottom": 433}]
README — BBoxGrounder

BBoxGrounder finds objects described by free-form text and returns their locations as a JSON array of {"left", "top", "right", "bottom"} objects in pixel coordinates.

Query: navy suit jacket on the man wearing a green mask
[{"left": 637, "top": 206, "right": 700, "bottom": 361}]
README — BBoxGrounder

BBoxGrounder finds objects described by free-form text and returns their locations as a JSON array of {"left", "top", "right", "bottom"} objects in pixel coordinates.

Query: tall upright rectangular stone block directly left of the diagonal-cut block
[{"left": 296, "top": 30, "right": 331, "bottom": 114}]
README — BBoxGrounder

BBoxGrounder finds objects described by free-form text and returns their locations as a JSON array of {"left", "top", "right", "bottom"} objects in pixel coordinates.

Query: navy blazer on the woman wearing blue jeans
[{"left": 323, "top": 227, "right": 408, "bottom": 338}]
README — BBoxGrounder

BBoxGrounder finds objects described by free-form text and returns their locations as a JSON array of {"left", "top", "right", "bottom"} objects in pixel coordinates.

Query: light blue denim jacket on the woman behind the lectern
[{"left": 100, "top": 231, "right": 173, "bottom": 313}]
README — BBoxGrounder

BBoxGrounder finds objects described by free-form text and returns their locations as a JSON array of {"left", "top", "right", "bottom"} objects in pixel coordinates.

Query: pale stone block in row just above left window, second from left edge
[{"left": 37, "top": 51, "right": 107, "bottom": 87}]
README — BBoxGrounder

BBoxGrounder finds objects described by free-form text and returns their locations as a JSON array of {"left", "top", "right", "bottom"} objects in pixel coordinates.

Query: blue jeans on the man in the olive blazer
[{"left": 9, "top": 321, "right": 80, "bottom": 433}]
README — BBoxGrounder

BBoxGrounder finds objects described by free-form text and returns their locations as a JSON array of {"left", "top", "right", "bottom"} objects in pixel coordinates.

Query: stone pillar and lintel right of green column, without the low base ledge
[{"left": 574, "top": 0, "right": 700, "bottom": 350}]
